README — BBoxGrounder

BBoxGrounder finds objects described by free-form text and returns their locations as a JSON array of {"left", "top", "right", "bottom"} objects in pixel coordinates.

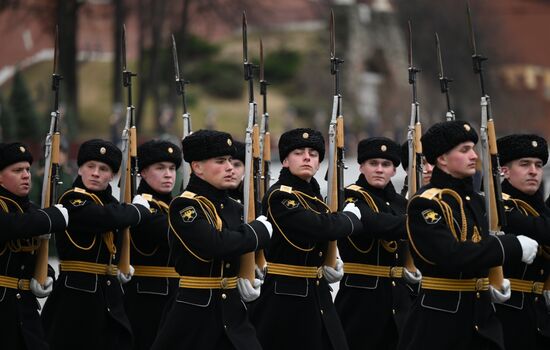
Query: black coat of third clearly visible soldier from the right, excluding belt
[{"left": 334, "top": 174, "right": 412, "bottom": 349}]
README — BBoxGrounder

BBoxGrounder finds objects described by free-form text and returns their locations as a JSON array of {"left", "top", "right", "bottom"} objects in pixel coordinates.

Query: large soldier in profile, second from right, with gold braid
[{"left": 398, "top": 120, "right": 537, "bottom": 349}]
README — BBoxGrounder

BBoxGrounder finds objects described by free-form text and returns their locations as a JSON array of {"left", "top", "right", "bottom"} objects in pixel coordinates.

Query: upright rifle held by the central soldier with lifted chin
[{"left": 324, "top": 10, "right": 345, "bottom": 267}]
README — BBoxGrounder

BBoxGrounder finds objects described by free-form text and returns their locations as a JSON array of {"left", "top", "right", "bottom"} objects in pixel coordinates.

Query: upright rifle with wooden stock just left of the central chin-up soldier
[{"left": 239, "top": 11, "right": 260, "bottom": 284}]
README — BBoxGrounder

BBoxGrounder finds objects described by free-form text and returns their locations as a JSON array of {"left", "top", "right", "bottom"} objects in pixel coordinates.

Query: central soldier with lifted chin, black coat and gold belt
[{"left": 251, "top": 128, "right": 363, "bottom": 350}]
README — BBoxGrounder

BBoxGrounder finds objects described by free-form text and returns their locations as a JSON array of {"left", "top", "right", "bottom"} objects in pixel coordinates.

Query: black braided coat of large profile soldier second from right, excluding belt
[{"left": 398, "top": 167, "right": 522, "bottom": 350}]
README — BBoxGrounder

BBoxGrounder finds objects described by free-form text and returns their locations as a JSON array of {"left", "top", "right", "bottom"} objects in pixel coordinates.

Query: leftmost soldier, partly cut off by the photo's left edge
[{"left": 0, "top": 142, "right": 68, "bottom": 350}]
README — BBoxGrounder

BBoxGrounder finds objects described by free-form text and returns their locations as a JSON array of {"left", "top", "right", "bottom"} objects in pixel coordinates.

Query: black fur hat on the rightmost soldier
[{"left": 497, "top": 134, "right": 548, "bottom": 165}]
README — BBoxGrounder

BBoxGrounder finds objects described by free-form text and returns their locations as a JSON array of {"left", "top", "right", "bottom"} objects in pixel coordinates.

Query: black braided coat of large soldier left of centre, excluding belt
[{"left": 152, "top": 175, "right": 269, "bottom": 350}]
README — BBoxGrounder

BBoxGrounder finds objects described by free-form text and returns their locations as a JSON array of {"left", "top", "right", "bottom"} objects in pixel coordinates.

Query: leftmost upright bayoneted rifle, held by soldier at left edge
[{"left": 34, "top": 26, "right": 63, "bottom": 285}]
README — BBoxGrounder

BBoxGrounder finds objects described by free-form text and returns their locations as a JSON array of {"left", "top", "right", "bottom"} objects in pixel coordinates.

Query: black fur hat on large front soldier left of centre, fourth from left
[{"left": 181, "top": 130, "right": 236, "bottom": 163}]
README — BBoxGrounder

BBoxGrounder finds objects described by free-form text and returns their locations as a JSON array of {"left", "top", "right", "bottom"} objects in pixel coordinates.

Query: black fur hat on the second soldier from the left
[{"left": 76, "top": 139, "right": 122, "bottom": 173}]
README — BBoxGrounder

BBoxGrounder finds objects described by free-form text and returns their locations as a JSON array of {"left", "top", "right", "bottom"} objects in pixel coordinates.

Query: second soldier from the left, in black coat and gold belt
[{"left": 42, "top": 139, "right": 150, "bottom": 349}]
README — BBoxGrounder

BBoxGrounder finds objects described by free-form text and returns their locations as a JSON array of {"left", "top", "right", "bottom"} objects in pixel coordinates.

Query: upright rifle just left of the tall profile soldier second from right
[{"left": 404, "top": 21, "right": 422, "bottom": 272}]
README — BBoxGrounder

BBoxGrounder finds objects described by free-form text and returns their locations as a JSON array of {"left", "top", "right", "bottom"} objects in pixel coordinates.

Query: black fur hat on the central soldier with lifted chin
[{"left": 279, "top": 128, "right": 325, "bottom": 163}]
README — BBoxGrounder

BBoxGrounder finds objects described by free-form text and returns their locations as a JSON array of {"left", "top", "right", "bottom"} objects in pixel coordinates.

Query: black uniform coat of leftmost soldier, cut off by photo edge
[{"left": 0, "top": 186, "right": 65, "bottom": 350}]
